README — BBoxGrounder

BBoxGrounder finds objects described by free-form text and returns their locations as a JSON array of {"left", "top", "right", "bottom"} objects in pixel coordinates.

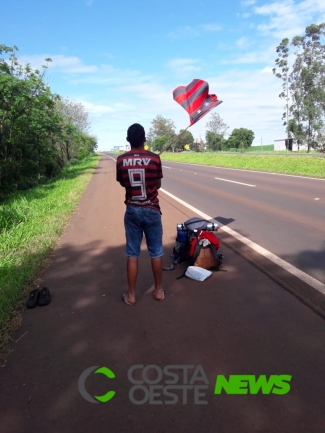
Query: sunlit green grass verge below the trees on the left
[{"left": 0, "top": 155, "right": 99, "bottom": 352}]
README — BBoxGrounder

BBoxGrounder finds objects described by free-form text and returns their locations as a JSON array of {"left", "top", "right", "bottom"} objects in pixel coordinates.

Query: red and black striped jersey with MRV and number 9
[{"left": 116, "top": 149, "right": 163, "bottom": 211}]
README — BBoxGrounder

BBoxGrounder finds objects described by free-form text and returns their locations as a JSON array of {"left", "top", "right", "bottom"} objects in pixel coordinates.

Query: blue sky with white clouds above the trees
[{"left": 0, "top": 0, "right": 325, "bottom": 150}]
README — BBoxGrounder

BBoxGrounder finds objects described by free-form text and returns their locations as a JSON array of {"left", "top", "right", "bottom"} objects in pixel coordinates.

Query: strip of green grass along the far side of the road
[{"left": 161, "top": 152, "right": 325, "bottom": 178}]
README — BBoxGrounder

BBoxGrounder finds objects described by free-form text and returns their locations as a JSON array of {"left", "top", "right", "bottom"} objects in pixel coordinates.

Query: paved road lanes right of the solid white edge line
[{"left": 156, "top": 157, "right": 325, "bottom": 283}]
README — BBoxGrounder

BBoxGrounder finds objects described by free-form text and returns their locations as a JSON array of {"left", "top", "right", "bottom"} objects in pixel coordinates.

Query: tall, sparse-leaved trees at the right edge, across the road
[{"left": 273, "top": 23, "right": 325, "bottom": 152}]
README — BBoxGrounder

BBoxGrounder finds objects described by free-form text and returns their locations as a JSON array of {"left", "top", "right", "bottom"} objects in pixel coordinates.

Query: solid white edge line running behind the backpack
[{"left": 159, "top": 188, "right": 325, "bottom": 295}]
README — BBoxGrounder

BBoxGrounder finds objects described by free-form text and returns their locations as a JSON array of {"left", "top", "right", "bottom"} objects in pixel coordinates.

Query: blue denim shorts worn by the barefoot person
[{"left": 124, "top": 206, "right": 164, "bottom": 259}]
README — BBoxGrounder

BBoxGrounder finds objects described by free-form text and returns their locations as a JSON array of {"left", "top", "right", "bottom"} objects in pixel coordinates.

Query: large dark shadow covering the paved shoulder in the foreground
[{"left": 0, "top": 233, "right": 325, "bottom": 433}]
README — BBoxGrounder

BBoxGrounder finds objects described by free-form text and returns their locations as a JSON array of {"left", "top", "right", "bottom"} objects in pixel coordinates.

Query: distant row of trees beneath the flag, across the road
[{"left": 147, "top": 113, "right": 255, "bottom": 152}]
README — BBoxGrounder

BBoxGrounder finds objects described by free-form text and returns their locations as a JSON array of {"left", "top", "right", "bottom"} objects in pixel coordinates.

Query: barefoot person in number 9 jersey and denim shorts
[{"left": 116, "top": 123, "right": 165, "bottom": 305}]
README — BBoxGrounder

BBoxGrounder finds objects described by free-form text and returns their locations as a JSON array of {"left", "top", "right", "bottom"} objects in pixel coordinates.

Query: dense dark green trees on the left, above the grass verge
[{"left": 0, "top": 44, "right": 97, "bottom": 198}]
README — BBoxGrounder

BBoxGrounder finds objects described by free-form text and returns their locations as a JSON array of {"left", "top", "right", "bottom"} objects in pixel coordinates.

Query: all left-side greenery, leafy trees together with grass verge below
[{"left": 0, "top": 44, "right": 99, "bottom": 358}]
